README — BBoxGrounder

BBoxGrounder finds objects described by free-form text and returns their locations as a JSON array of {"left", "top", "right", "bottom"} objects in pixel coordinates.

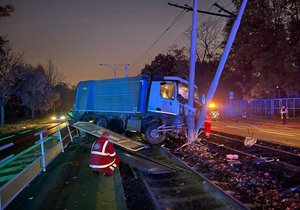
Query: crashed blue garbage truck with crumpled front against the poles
[{"left": 73, "top": 74, "right": 200, "bottom": 144}]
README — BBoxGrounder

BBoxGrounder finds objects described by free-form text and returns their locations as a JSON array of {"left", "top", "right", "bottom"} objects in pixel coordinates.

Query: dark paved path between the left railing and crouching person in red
[{"left": 6, "top": 143, "right": 125, "bottom": 210}]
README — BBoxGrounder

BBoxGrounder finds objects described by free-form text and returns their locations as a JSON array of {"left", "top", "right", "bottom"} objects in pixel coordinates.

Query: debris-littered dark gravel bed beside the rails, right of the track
[{"left": 164, "top": 135, "right": 300, "bottom": 210}]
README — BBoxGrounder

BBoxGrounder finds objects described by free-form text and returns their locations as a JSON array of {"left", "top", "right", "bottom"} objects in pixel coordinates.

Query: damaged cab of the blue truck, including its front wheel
[{"left": 144, "top": 76, "right": 199, "bottom": 144}]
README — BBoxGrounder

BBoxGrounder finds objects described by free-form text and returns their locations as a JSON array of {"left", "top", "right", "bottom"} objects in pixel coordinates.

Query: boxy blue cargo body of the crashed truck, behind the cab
[{"left": 75, "top": 76, "right": 148, "bottom": 114}]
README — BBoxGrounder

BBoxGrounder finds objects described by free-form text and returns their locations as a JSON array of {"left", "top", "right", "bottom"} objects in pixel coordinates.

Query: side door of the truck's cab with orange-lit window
[{"left": 148, "top": 81, "right": 179, "bottom": 115}]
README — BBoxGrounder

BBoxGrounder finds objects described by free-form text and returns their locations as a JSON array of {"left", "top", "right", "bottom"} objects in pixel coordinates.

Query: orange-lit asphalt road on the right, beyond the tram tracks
[{"left": 212, "top": 119, "right": 300, "bottom": 148}]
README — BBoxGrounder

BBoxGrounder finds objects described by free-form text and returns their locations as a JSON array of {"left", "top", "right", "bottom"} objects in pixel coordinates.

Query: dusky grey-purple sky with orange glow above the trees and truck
[{"left": 0, "top": 0, "right": 232, "bottom": 84}]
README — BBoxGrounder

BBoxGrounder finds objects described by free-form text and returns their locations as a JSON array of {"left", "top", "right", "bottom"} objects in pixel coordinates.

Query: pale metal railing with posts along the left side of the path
[{"left": 0, "top": 123, "right": 73, "bottom": 210}]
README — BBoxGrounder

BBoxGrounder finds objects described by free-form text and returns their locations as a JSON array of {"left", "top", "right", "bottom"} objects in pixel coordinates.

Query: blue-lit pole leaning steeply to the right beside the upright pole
[{"left": 196, "top": 0, "right": 247, "bottom": 133}]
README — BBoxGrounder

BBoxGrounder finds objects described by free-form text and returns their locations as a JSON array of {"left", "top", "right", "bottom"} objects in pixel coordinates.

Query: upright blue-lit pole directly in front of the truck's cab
[{"left": 187, "top": 0, "right": 198, "bottom": 143}]
